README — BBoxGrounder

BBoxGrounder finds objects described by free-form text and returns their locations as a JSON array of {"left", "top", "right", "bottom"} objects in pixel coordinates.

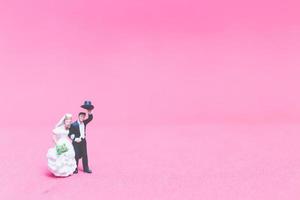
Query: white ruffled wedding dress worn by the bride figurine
[{"left": 47, "top": 126, "right": 76, "bottom": 177}]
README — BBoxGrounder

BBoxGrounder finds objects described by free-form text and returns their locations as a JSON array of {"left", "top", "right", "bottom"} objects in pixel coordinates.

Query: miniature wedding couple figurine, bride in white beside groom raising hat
[{"left": 47, "top": 101, "right": 94, "bottom": 177}]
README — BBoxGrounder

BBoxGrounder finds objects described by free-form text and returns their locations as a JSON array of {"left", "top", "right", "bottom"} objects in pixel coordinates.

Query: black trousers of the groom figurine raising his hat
[{"left": 73, "top": 139, "right": 89, "bottom": 171}]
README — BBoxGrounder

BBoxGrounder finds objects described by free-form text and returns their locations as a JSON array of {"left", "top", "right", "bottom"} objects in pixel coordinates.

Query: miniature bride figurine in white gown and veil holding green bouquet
[{"left": 47, "top": 114, "right": 77, "bottom": 177}]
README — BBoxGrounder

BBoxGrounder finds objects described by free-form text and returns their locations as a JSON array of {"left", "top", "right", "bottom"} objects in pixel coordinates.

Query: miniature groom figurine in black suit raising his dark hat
[{"left": 69, "top": 101, "right": 94, "bottom": 174}]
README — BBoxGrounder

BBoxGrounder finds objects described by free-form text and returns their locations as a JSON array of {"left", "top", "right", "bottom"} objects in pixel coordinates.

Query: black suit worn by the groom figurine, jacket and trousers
[{"left": 69, "top": 114, "right": 93, "bottom": 171}]
